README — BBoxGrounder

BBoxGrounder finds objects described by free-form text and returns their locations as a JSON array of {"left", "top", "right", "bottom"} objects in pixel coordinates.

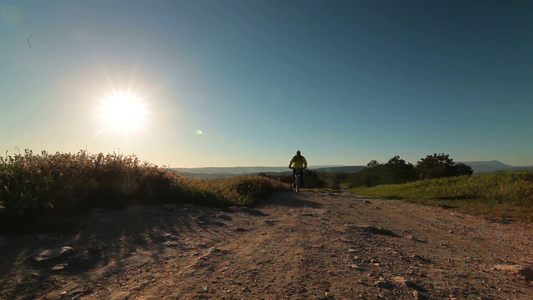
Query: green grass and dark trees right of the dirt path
[{"left": 277, "top": 153, "right": 533, "bottom": 222}]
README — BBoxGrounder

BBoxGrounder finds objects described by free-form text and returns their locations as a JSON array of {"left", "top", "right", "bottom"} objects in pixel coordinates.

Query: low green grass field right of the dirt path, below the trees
[{"left": 352, "top": 171, "right": 533, "bottom": 221}]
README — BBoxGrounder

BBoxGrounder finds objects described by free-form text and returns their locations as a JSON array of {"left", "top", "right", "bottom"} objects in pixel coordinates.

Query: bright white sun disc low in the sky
[{"left": 98, "top": 91, "right": 148, "bottom": 134}]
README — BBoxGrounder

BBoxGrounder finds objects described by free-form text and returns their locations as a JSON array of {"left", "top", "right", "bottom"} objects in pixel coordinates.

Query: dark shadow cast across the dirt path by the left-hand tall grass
[{"left": 0, "top": 205, "right": 236, "bottom": 299}]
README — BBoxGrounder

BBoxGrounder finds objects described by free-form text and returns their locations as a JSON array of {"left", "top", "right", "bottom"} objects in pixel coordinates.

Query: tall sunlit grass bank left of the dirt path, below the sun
[{"left": 0, "top": 150, "right": 283, "bottom": 232}]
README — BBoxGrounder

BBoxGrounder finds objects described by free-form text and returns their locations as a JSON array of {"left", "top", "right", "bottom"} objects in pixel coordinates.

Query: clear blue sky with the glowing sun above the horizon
[{"left": 0, "top": 0, "right": 533, "bottom": 168}]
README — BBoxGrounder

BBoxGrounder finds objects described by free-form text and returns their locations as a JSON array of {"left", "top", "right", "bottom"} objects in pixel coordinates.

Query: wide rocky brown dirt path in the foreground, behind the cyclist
[{"left": 0, "top": 191, "right": 533, "bottom": 299}]
